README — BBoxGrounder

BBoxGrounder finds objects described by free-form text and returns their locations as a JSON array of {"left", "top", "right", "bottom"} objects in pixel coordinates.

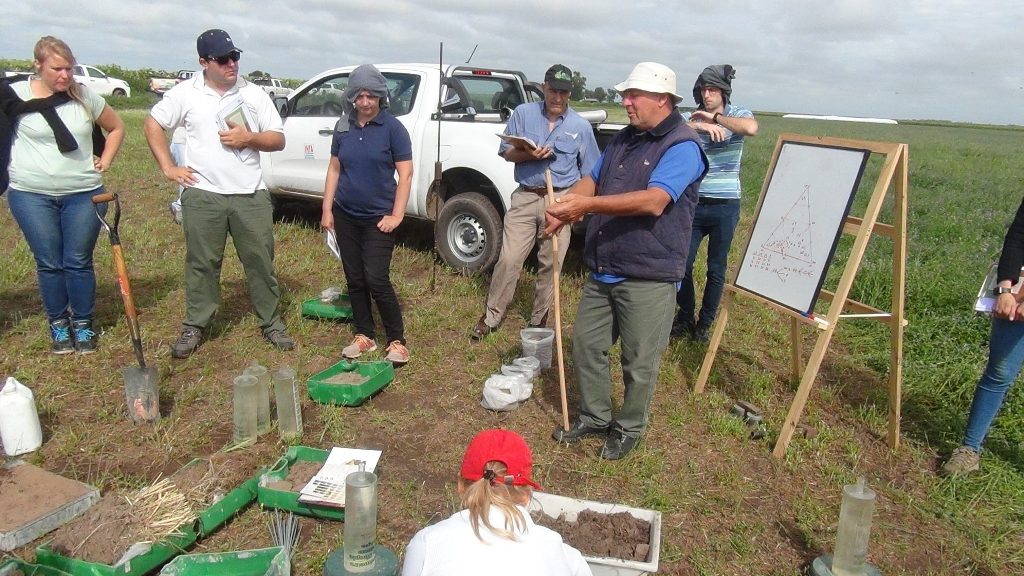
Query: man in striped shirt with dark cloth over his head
[{"left": 672, "top": 65, "right": 758, "bottom": 342}]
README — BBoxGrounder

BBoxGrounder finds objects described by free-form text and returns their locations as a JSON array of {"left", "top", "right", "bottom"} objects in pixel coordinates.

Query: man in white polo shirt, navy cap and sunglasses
[{"left": 144, "top": 30, "right": 295, "bottom": 358}]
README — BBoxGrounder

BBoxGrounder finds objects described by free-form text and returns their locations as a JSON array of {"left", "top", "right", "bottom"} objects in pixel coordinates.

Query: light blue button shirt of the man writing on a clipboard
[{"left": 498, "top": 101, "right": 600, "bottom": 188}]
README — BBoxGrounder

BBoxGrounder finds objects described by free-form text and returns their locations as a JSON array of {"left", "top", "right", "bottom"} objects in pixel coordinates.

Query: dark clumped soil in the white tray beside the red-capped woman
[{"left": 534, "top": 510, "right": 650, "bottom": 562}]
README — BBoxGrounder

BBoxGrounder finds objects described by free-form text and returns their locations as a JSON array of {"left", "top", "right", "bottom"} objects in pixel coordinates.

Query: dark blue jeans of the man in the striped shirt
[{"left": 676, "top": 200, "right": 739, "bottom": 327}]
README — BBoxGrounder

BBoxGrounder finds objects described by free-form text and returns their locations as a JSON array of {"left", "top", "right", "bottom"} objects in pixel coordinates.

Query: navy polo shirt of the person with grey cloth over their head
[{"left": 331, "top": 109, "right": 413, "bottom": 218}]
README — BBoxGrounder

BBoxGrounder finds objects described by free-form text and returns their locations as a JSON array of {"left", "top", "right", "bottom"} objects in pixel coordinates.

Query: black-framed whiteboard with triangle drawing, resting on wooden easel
[{"left": 735, "top": 141, "right": 870, "bottom": 315}]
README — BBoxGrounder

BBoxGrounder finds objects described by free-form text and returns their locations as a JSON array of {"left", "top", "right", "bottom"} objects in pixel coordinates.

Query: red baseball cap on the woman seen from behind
[{"left": 460, "top": 428, "right": 542, "bottom": 490}]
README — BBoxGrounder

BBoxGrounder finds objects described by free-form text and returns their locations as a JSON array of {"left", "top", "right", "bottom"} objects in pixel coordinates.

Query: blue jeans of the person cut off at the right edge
[{"left": 964, "top": 318, "right": 1024, "bottom": 451}]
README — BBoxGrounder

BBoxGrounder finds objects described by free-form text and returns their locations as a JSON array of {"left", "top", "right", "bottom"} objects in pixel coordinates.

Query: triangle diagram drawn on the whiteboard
[{"left": 751, "top": 186, "right": 814, "bottom": 282}]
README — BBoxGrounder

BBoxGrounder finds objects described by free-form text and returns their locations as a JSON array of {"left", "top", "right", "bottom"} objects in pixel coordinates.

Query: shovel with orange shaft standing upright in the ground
[{"left": 92, "top": 193, "right": 160, "bottom": 422}]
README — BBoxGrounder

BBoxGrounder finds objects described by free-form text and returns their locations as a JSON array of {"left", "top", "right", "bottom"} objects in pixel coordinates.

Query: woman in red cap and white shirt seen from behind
[{"left": 401, "top": 429, "right": 591, "bottom": 576}]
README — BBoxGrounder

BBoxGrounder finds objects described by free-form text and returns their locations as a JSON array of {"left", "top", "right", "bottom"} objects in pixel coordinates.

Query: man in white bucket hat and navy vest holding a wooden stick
[{"left": 545, "top": 63, "right": 708, "bottom": 460}]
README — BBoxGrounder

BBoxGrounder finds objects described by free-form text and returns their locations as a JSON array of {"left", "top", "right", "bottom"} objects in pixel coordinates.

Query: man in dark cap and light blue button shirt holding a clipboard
[{"left": 470, "top": 64, "right": 599, "bottom": 339}]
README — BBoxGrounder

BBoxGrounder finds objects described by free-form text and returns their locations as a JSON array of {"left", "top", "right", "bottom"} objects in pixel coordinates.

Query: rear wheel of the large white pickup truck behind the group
[{"left": 434, "top": 192, "right": 502, "bottom": 274}]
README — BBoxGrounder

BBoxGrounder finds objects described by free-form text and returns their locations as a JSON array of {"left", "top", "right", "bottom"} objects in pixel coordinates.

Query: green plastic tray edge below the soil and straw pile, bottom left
[{"left": 36, "top": 520, "right": 200, "bottom": 576}]
